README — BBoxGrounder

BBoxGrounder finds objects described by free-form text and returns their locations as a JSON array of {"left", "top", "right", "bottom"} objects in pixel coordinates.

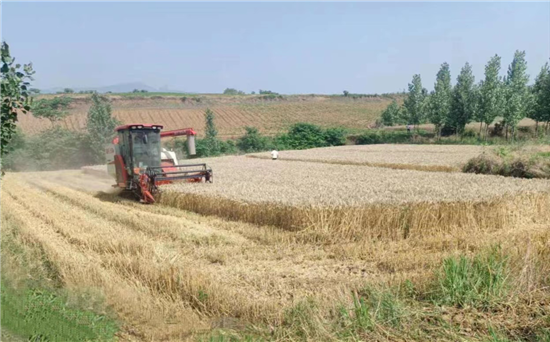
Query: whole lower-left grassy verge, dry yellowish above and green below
[{"left": 0, "top": 215, "right": 118, "bottom": 342}]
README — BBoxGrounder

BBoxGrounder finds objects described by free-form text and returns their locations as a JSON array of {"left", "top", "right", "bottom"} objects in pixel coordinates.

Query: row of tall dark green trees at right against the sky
[{"left": 380, "top": 51, "right": 550, "bottom": 138}]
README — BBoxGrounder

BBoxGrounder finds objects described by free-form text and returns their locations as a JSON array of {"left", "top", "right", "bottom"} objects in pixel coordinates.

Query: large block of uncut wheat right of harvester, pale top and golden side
[{"left": 160, "top": 157, "right": 550, "bottom": 242}]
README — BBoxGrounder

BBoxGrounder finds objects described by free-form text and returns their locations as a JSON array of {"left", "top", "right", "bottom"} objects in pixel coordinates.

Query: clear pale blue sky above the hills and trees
[{"left": 2, "top": 2, "right": 550, "bottom": 94}]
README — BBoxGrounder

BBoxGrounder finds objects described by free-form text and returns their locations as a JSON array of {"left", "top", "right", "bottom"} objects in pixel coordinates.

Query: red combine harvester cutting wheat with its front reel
[{"left": 105, "top": 124, "right": 213, "bottom": 203}]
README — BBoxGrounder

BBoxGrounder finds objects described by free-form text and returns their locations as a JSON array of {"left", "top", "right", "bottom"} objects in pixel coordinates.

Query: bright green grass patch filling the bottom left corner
[{"left": 1, "top": 280, "right": 118, "bottom": 342}]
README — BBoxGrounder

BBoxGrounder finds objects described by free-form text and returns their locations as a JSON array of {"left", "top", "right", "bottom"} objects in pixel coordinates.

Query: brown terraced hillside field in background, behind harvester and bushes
[{"left": 19, "top": 96, "right": 391, "bottom": 138}]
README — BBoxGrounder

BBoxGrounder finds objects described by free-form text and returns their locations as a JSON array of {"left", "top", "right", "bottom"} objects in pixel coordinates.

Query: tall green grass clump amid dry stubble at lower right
[{"left": 434, "top": 248, "right": 510, "bottom": 309}]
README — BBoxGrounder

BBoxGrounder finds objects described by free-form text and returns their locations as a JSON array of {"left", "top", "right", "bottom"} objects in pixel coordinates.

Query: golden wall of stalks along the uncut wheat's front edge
[{"left": 160, "top": 191, "right": 550, "bottom": 243}]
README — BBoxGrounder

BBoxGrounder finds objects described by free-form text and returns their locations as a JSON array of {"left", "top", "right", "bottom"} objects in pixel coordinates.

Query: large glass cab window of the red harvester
[{"left": 131, "top": 129, "right": 160, "bottom": 169}]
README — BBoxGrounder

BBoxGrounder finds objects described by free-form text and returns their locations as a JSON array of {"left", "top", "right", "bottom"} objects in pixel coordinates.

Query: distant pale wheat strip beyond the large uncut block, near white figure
[{"left": 248, "top": 144, "right": 487, "bottom": 172}]
